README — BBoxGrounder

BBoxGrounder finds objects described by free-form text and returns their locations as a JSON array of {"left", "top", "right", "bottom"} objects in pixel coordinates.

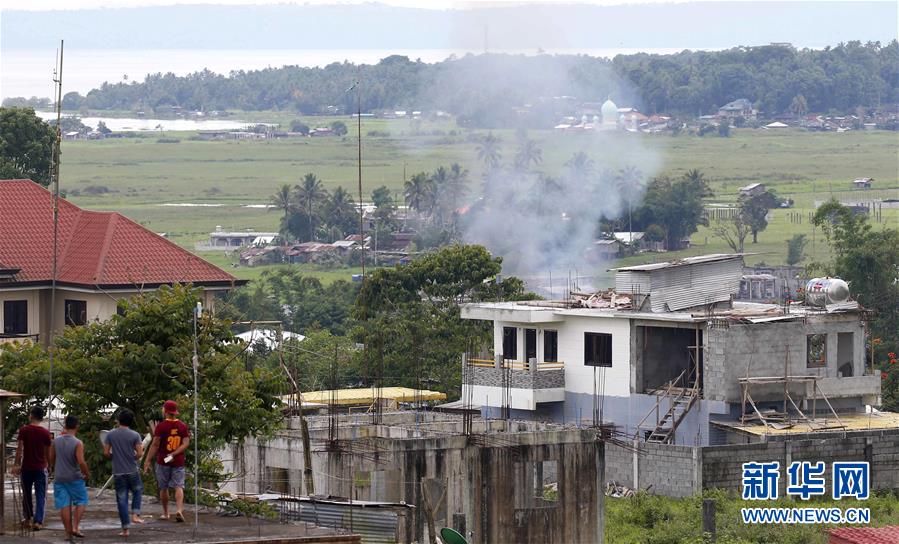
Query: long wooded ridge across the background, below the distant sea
[{"left": 49, "top": 40, "right": 899, "bottom": 127}]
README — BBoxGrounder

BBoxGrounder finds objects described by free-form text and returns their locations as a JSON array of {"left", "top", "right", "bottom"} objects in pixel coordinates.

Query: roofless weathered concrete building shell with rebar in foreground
[{"left": 221, "top": 412, "right": 604, "bottom": 543}]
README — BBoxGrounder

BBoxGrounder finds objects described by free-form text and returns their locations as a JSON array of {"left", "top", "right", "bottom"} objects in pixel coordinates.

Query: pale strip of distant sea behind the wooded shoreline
[{"left": 0, "top": 46, "right": 679, "bottom": 98}]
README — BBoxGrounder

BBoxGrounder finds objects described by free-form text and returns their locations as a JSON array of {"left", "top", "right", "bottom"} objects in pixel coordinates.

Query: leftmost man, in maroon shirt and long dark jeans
[{"left": 13, "top": 406, "right": 52, "bottom": 531}]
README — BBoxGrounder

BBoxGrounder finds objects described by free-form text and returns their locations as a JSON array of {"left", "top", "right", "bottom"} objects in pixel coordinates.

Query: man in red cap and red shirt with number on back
[{"left": 144, "top": 400, "right": 190, "bottom": 522}]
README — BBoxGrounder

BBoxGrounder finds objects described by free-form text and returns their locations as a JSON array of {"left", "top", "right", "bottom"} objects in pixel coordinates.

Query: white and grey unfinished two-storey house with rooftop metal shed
[{"left": 462, "top": 254, "right": 880, "bottom": 445}]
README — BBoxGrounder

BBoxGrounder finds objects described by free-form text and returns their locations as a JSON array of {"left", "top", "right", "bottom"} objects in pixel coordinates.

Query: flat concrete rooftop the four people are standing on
[{"left": 0, "top": 488, "right": 360, "bottom": 544}]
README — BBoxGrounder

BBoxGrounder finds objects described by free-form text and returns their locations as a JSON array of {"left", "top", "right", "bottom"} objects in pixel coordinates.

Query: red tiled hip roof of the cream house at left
[{"left": 0, "top": 179, "right": 243, "bottom": 288}]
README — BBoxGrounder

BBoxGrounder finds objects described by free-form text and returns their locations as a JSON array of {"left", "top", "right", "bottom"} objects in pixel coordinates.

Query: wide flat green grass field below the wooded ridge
[{"left": 61, "top": 117, "right": 899, "bottom": 279}]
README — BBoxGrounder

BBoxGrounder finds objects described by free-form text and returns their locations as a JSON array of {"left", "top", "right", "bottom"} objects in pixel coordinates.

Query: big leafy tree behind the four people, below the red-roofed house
[{"left": 0, "top": 285, "right": 283, "bottom": 482}]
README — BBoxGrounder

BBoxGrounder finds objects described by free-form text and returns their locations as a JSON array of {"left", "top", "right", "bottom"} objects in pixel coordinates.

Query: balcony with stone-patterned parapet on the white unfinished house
[{"left": 463, "top": 357, "right": 565, "bottom": 410}]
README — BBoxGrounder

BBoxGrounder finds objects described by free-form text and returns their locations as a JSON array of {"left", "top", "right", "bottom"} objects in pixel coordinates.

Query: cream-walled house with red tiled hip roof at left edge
[{"left": 0, "top": 179, "right": 245, "bottom": 344}]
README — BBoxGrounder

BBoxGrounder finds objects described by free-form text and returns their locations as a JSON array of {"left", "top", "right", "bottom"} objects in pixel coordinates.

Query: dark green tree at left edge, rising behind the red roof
[{"left": 0, "top": 108, "right": 56, "bottom": 187}]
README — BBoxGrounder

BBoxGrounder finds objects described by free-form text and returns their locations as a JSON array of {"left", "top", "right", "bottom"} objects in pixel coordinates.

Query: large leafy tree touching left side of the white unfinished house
[{"left": 354, "top": 245, "right": 528, "bottom": 395}]
